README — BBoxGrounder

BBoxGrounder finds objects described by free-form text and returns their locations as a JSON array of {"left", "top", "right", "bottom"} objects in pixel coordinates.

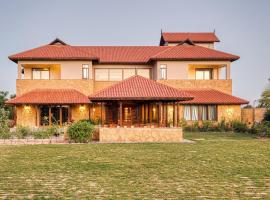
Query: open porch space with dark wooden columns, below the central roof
[{"left": 90, "top": 100, "right": 180, "bottom": 128}]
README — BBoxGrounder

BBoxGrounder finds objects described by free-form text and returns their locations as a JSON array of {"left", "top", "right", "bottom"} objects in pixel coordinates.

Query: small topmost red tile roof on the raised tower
[{"left": 160, "top": 32, "right": 219, "bottom": 45}]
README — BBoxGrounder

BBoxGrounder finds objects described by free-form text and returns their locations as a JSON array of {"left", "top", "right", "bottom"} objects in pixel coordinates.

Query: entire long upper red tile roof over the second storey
[{"left": 9, "top": 37, "right": 239, "bottom": 64}]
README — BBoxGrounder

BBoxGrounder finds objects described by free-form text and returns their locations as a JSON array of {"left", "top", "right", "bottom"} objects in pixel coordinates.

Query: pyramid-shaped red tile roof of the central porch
[{"left": 89, "top": 75, "right": 193, "bottom": 101}]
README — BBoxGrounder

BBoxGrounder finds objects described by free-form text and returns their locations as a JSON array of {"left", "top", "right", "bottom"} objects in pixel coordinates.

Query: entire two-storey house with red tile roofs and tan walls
[{"left": 8, "top": 32, "right": 248, "bottom": 127}]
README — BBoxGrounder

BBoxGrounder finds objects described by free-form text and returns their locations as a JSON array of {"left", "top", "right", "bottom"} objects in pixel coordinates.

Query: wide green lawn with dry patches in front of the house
[{"left": 0, "top": 133, "right": 270, "bottom": 199}]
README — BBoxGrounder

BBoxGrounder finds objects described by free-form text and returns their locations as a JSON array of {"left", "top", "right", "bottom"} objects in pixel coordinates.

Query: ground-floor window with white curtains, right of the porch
[{"left": 184, "top": 105, "right": 217, "bottom": 121}]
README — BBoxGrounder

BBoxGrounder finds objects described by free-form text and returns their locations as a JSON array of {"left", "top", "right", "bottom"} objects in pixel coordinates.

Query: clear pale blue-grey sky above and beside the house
[{"left": 0, "top": 0, "right": 270, "bottom": 103}]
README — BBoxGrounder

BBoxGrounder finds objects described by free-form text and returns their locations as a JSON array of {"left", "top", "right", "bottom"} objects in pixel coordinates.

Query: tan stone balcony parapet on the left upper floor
[{"left": 16, "top": 79, "right": 94, "bottom": 96}]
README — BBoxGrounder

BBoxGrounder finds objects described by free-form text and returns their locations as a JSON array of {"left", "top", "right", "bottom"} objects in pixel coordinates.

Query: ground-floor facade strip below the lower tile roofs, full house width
[{"left": 15, "top": 101, "right": 241, "bottom": 127}]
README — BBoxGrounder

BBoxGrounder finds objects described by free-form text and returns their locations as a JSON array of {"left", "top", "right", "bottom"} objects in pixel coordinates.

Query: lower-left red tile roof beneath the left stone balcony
[{"left": 6, "top": 89, "right": 90, "bottom": 104}]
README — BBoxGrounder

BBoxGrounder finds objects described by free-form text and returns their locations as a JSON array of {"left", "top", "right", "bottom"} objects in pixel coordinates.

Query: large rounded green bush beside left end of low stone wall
[{"left": 67, "top": 121, "right": 94, "bottom": 143}]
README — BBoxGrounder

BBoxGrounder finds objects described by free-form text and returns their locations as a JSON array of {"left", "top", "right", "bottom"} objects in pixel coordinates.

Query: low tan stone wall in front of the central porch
[{"left": 99, "top": 127, "right": 183, "bottom": 142}]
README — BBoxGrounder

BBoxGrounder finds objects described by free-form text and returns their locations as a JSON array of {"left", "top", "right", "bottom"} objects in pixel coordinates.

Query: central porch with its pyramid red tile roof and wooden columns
[{"left": 89, "top": 76, "right": 193, "bottom": 127}]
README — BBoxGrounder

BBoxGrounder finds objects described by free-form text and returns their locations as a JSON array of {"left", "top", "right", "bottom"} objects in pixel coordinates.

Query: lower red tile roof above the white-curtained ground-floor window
[{"left": 181, "top": 89, "right": 248, "bottom": 105}]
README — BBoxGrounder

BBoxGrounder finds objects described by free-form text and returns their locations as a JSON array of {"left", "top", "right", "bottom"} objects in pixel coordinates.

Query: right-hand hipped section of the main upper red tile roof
[{"left": 151, "top": 44, "right": 239, "bottom": 61}]
